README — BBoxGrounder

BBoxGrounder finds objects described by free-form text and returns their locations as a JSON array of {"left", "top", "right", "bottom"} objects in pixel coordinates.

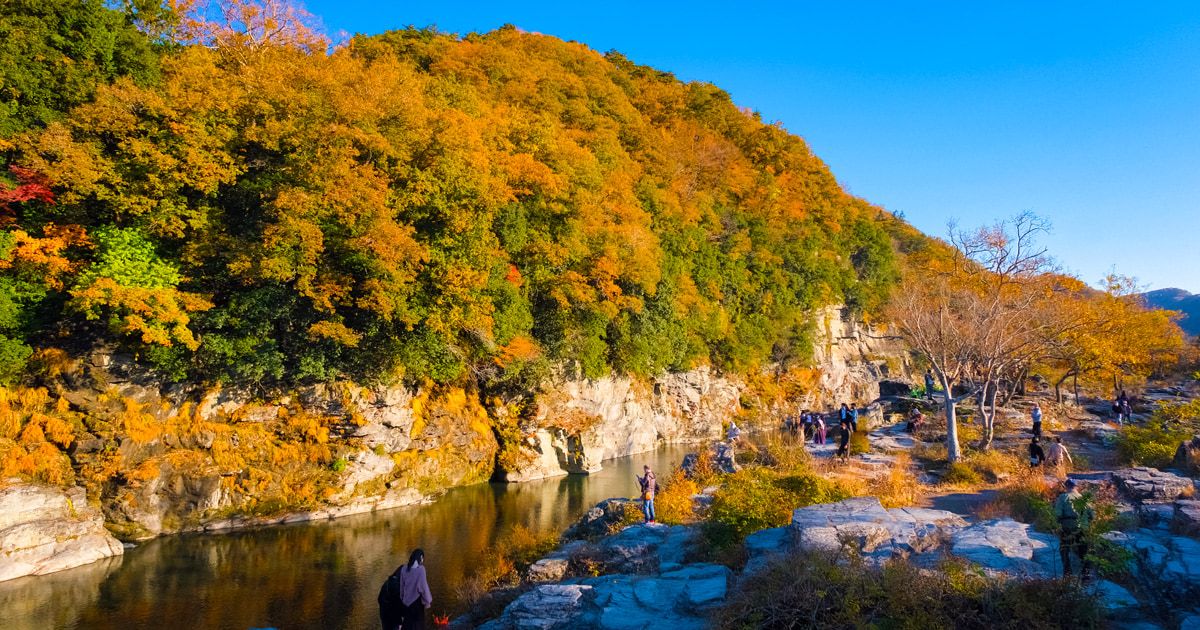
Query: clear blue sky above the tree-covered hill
[{"left": 306, "top": 0, "right": 1200, "bottom": 292}]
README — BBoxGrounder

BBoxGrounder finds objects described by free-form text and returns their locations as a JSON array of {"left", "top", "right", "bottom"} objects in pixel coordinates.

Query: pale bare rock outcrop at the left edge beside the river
[{"left": 0, "top": 484, "right": 124, "bottom": 581}]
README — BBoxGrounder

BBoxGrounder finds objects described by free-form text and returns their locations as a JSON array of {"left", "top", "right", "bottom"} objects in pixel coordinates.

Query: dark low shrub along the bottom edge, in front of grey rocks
[{"left": 714, "top": 553, "right": 1103, "bottom": 630}]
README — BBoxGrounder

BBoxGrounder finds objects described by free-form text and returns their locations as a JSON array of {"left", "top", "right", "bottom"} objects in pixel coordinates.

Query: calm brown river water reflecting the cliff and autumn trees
[{"left": 0, "top": 446, "right": 688, "bottom": 630}]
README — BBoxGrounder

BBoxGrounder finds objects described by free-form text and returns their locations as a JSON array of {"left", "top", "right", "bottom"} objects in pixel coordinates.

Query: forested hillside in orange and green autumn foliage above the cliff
[{"left": 0, "top": 0, "right": 924, "bottom": 388}]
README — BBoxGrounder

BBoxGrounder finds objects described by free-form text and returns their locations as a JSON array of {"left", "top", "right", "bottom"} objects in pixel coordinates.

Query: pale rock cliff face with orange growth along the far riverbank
[{"left": 2, "top": 307, "right": 908, "bottom": 571}]
